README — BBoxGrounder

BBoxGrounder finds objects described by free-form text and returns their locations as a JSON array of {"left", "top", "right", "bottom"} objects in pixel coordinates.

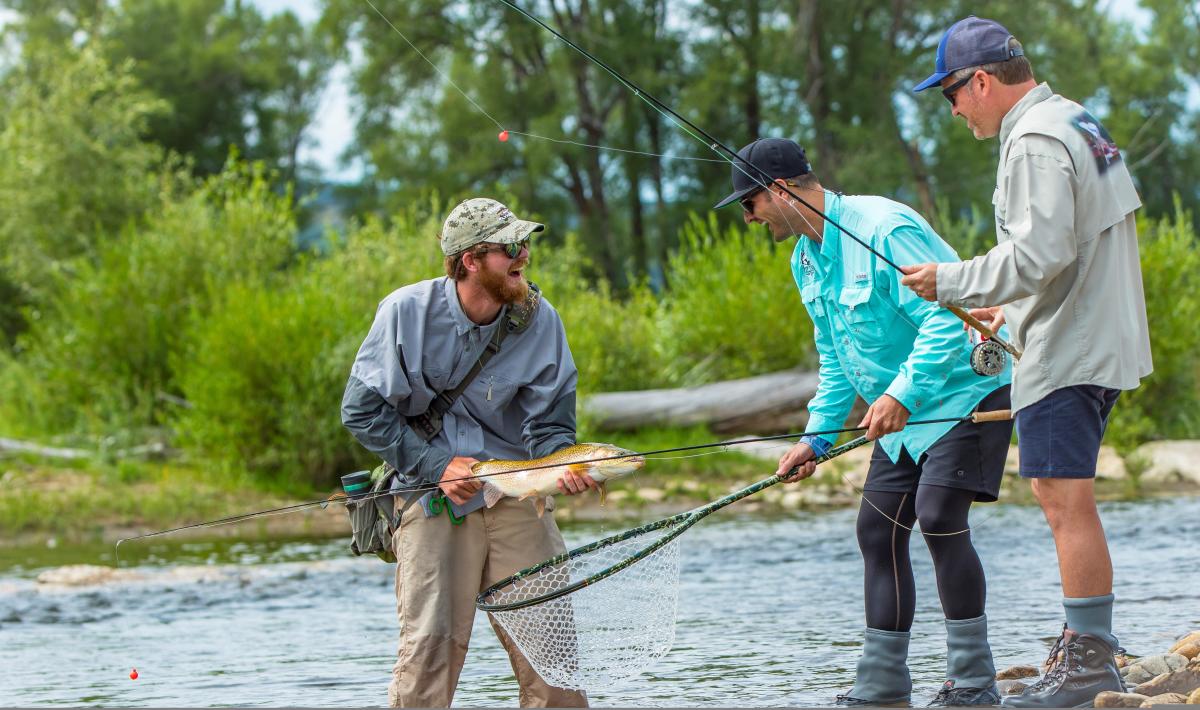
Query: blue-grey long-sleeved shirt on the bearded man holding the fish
[{"left": 342, "top": 276, "right": 578, "bottom": 516}]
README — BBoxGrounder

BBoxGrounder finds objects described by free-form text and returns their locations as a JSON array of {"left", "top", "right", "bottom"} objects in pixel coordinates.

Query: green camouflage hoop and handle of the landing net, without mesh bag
[{"left": 475, "top": 437, "right": 870, "bottom": 612}]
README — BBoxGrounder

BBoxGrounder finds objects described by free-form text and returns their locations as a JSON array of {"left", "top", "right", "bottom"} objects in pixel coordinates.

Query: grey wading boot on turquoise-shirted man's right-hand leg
[{"left": 929, "top": 616, "right": 1000, "bottom": 708}]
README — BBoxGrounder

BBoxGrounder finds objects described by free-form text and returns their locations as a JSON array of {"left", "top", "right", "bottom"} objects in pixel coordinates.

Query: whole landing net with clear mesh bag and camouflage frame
[{"left": 475, "top": 437, "right": 868, "bottom": 690}]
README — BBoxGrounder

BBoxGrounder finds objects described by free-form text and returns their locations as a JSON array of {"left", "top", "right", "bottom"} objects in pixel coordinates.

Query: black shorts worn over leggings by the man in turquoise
[{"left": 863, "top": 385, "right": 1013, "bottom": 503}]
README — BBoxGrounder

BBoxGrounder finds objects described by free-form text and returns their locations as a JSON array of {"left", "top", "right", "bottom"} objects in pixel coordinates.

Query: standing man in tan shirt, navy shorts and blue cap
[{"left": 901, "top": 16, "right": 1152, "bottom": 708}]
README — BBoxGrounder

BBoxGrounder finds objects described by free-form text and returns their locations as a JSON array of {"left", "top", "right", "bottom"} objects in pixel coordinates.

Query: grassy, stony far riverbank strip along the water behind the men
[{"left": 0, "top": 441, "right": 1200, "bottom": 547}]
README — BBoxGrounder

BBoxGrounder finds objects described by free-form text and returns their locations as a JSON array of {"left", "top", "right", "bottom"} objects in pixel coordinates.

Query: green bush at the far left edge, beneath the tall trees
[{"left": 0, "top": 164, "right": 295, "bottom": 432}]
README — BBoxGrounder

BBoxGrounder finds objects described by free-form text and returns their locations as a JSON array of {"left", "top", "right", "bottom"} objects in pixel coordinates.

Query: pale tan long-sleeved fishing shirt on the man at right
[{"left": 937, "top": 84, "right": 1152, "bottom": 411}]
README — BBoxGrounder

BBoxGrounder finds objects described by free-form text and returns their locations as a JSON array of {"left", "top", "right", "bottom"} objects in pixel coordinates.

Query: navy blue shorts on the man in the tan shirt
[{"left": 1016, "top": 385, "right": 1121, "bottom": 479}]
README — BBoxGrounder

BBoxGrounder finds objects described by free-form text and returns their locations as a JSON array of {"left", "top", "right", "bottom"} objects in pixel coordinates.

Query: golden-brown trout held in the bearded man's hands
[{"left": 470, "top": 444, "right": 646, "bottom": 517}]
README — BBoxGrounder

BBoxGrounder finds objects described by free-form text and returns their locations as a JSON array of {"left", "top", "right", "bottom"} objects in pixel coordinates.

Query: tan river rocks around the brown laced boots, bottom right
[{"left": 996, "top": 630, "right": 1200, "bottom": 708}]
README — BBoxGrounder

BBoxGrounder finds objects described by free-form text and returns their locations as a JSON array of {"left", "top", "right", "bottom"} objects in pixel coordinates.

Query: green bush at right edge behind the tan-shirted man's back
[{"left": 1105, "top": 201, "right": 1200, "bottom": 451}]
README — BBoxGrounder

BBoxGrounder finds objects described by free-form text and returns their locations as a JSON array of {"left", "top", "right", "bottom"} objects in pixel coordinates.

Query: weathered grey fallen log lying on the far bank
[{"left": 580, "top": 371, "right": 844, "bottom": 434}]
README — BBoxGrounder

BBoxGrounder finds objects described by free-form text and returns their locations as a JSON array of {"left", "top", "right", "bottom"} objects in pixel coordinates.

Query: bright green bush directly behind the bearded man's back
[{"left": 173, "top": 205, "right": 440, "bottom": 483}]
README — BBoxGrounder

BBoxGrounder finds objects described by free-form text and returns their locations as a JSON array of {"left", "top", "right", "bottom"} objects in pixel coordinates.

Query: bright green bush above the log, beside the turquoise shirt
[{"left": 659, "top": 213, "right": 815, "bottom": 385}]
